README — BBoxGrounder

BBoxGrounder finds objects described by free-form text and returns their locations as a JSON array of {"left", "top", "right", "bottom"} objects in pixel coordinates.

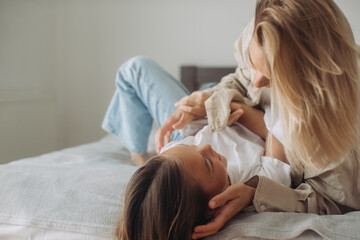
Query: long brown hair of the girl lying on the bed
[{"left": 115, "top": 156, "right": 207, "bottom": 240}]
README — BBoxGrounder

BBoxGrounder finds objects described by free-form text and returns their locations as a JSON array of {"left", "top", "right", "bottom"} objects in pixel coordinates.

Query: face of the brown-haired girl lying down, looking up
[{"left": 161, "top": 144, "right": 230, "bottom": 199}]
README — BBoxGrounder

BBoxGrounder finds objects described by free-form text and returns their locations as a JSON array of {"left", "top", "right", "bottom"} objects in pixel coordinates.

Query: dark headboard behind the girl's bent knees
[{"left": 181, "top": 66, "right": 236, "bottom": 92}]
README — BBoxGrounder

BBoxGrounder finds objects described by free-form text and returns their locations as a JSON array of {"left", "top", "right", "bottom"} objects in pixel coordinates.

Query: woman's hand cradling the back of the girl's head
[{"left": 191, "top": 183, "right": 255, "bottom": 239}]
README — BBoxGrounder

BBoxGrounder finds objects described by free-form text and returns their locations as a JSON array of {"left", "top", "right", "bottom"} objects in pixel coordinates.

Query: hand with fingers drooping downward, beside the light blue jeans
[{"left": 155, "top": 109, "right": 196, "bottom": 153}]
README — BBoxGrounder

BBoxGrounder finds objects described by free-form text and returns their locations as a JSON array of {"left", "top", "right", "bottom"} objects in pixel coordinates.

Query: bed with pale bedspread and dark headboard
[{"left": 0, "top": 66, "right": 360, "bottom": 240}]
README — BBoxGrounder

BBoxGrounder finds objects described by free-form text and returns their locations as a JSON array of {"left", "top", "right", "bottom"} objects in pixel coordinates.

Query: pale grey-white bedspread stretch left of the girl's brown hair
[{"left": 0, "top": 137, "right": 137, "bottom": 237}]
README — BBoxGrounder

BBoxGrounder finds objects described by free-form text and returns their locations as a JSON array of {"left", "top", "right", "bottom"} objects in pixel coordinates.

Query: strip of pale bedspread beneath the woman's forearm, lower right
[{"left": 207, "top": 212, "right": 360, "bottom": 240}]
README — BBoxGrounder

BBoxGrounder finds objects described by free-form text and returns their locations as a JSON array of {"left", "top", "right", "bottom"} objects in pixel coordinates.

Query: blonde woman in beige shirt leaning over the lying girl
[{"left": 157, "top": 0, "right": 360, "bottom": 239}]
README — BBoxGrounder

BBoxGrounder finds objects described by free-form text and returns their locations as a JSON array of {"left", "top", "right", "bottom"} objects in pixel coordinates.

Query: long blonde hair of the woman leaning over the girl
[{"left": 254, "top": 0, "right": 359, "bottom": 170}]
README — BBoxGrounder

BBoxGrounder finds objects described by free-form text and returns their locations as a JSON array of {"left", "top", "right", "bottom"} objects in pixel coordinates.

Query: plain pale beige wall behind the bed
[{"left": 0, "top": 0, "right": 360, "bottom": 162}]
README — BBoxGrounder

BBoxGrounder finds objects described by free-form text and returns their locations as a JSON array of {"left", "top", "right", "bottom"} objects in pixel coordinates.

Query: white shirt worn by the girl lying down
[{"left": 161, "top": 120, "right": 291, "bottom": 186}]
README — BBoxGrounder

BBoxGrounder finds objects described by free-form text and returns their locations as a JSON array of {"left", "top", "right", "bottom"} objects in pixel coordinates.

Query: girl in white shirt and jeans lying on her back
[{"left": 103, "top": 57, "right": 290, "bottom": 240}]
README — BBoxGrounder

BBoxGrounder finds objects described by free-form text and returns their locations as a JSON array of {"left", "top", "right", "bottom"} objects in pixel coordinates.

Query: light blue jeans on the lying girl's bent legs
[{"left": 102, "top": 57, "right": 189, "bottom": 154}]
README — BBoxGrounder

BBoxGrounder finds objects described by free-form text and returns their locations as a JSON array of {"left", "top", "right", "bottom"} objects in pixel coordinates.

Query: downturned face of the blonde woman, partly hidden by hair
[{"left": 249, "top": 37, "right": 270, "bottom": 88}]
